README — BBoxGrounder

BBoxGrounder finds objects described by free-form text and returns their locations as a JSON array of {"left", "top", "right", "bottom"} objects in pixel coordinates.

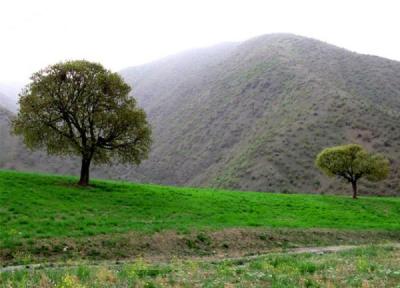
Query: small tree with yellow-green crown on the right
[{"left": 315, "top": 144, "right": 389, "bottom": 199}]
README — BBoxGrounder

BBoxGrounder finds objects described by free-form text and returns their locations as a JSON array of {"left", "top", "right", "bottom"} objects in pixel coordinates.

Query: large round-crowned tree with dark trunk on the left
[{"left": 12, "top": 60, "right": 151, "bottom": 185}]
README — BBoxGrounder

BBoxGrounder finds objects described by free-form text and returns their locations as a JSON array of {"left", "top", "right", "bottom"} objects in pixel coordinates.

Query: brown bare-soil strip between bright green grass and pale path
[{"left": 0, "top": 228, "right": 400, "bottom": 267}]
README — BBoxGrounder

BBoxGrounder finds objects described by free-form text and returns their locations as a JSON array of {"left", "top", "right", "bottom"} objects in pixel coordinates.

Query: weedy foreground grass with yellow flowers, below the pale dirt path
[{"left": 0, "top": 246, "right": 400, "bottom": 288}]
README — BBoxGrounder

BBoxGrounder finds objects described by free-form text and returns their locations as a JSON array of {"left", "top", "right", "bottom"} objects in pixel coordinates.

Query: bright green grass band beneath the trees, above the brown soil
[{"left": 0, "top": 171, "right": 400, "bottom": 245}]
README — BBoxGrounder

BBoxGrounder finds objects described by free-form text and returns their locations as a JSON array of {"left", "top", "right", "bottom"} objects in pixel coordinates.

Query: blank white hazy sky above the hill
[{"left": 0, "top": 0, "right": 400, "bottom": 82}]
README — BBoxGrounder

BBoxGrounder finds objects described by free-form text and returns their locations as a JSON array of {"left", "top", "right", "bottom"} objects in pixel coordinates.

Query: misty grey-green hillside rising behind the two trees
[{"left": 3, "top": 34, "right": 400, "bottom": 195}]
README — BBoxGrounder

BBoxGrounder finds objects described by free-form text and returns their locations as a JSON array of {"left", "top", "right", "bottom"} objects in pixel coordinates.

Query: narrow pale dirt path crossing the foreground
[{"left": 0, "top": 243, "right": 400, "bottom": 273}]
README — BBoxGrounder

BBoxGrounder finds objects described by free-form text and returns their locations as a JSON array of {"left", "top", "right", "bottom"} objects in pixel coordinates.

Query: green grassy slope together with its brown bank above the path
[{"left": 0, "top": 171, "right": 400, "bottom": 262}]
